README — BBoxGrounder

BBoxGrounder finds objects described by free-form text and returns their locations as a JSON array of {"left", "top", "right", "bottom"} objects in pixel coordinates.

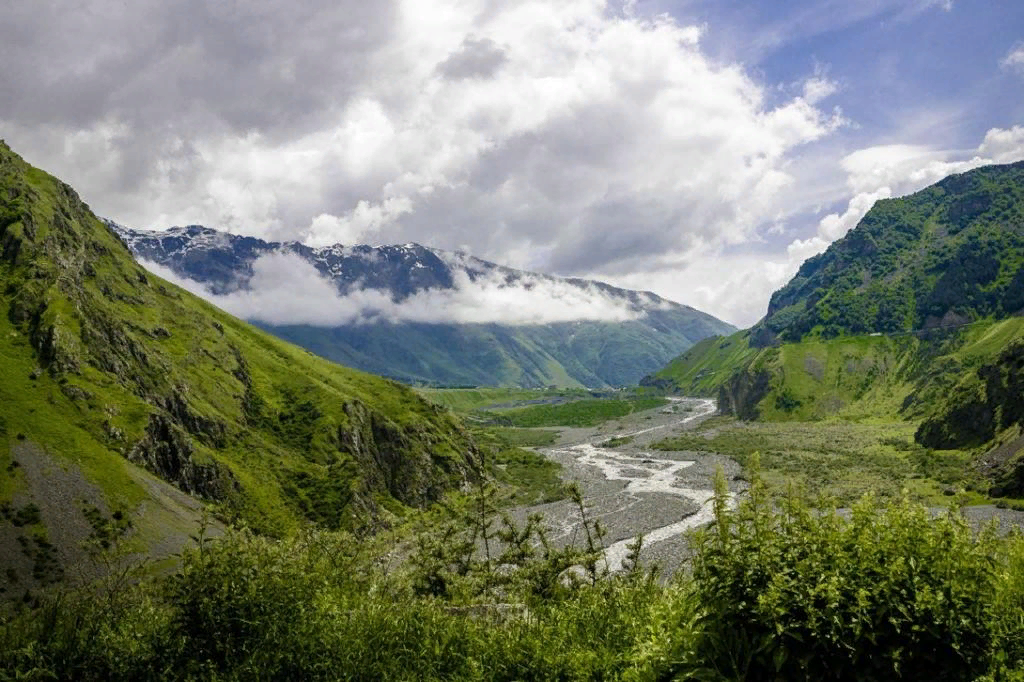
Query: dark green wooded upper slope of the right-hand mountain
[{"left": 754, "top": 162, "right": 1024, "bottom": 345}]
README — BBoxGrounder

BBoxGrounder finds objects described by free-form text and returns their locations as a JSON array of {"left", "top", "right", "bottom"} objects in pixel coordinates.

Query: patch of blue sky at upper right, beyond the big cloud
[{"left": 692, "top": 0, "right": 1024, "bottom": 148}]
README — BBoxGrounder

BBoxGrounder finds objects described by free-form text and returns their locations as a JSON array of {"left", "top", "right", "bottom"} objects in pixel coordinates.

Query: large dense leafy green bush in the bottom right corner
[{"left": 676, "top": 458, "right": 1024, "bottom": 680}]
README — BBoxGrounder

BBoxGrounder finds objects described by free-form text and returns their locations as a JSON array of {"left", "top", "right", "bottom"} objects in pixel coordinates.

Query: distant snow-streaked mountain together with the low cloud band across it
[{"left": 108, "top": 222, "right": 735, "bottom": 388}]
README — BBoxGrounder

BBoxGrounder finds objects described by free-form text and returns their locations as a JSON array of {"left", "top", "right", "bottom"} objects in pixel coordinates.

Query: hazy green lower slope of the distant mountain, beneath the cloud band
[{"left": 261, "top": 309, "right": 735, "bottom": 388}]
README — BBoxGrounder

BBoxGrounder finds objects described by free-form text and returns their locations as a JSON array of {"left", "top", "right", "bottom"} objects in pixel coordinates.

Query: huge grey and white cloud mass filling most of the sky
[{"left": 0, "top": 0, "right": 844, "bottom": 299}]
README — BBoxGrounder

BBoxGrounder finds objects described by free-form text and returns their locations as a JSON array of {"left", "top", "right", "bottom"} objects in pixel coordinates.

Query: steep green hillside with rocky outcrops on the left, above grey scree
[{"left": 0, "top": 143, "right": 475, "bottom": 585}]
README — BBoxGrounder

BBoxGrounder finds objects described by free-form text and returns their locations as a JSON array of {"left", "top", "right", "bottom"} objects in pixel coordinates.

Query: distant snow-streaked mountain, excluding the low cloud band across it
[{"left": 110, "top": 223, "right": 735, "bottom": 388}]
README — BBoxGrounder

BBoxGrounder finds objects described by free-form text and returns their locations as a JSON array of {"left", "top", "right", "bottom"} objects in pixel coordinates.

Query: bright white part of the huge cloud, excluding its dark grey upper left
[{"left": 8, "top": 0, "right": 844, "bottom": 273}]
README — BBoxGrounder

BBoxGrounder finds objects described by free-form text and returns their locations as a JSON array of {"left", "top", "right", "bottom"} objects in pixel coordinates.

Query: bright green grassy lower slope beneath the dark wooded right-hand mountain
[{"left": 645, "top": 317, "right": 1024, "bottom": 419}]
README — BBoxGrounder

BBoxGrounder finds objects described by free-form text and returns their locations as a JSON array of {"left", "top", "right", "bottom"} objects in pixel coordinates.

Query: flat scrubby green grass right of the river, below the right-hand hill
[{"left": 653, "top": 417, "right": 987, "bottom": 505}]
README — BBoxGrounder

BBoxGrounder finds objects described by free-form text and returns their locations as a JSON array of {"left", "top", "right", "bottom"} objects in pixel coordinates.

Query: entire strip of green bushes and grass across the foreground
[{"left": 0, "top": 458, "right": 1024, "bottom": 680}]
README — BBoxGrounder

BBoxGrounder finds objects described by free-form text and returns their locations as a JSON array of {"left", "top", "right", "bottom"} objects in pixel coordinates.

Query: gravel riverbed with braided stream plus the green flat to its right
[{"left": 513, "top": 398, "right": 1024, "bottom": 577}]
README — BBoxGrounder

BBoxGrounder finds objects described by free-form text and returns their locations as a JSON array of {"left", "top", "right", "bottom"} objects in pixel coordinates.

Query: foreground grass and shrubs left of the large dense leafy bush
[{"left": 0, "top": 488, "right": 674, "bottom": 680}]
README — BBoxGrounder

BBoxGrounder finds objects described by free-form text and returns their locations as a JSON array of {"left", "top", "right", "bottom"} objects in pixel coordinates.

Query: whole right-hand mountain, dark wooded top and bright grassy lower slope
[{"left": 641, "top": 163, "right": 1024, "bottom": 495}]
